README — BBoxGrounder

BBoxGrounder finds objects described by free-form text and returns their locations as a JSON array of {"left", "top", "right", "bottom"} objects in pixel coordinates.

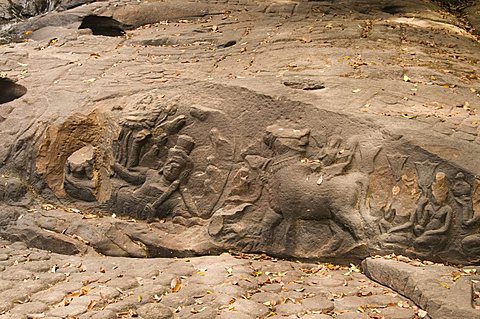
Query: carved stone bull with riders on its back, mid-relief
[{"left": 210, "top": 125, "right": 372, "bottom": 255}]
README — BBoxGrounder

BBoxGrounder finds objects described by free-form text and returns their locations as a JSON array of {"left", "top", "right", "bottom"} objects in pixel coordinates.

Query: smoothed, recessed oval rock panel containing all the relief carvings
[{"left": 3, "top": 85, "right": 480, "bottom": 263}]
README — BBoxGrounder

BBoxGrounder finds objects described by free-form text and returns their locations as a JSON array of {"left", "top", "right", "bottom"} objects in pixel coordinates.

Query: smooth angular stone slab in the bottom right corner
[{"left": 362, "top": 258, "right": 480, "bottom": 319}]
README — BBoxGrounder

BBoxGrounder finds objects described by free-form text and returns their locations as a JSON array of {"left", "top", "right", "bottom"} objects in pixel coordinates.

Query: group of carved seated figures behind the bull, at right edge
[{"left": 372, "top": 157, "right": 480, "bottom": 260}]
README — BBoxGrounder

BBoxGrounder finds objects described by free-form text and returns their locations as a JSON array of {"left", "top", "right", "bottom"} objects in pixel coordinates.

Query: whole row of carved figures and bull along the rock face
[{"left": 51, "top": 96, "right": 480, "bottom": 264}]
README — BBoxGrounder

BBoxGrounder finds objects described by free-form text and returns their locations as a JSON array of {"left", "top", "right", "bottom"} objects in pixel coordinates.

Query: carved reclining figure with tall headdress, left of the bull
[{"left": 115, "top": 135, "right": 198, "bottom": 225}]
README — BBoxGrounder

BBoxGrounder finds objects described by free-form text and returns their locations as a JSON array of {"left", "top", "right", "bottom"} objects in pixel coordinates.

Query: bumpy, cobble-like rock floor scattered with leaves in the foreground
[{"left": 0, "top": 242, "right": 426, "bottom": 319}]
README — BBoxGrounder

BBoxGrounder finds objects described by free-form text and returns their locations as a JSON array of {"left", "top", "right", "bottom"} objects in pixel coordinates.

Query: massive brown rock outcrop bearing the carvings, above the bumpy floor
[{"left": 0, "top": 0, "right": 480, "bottom": 266}]
